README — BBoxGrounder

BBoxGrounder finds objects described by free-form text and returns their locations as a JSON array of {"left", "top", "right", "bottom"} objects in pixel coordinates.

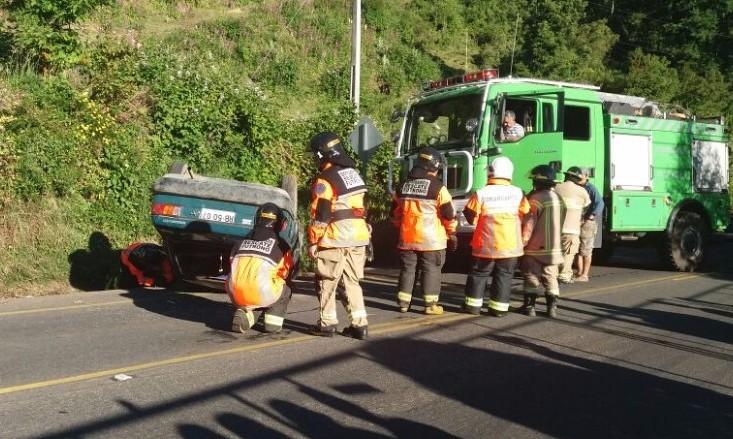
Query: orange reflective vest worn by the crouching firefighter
[{"left": 224, "top": 228, "right": 294, "bottom": 309}]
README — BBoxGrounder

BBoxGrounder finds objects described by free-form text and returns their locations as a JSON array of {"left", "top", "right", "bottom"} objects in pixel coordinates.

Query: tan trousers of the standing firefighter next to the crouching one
[{"left": 316, "top": 246, "right": 368, "bottom": 327}]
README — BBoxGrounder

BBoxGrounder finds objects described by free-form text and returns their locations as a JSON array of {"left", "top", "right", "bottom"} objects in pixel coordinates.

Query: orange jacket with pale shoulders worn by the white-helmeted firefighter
[{"left": 463, "top": 178, "right": 529, "bottom": 259}]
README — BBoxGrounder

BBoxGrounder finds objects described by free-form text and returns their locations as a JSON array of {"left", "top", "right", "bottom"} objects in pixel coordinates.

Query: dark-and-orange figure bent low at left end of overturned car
[{"left": 120, "top": 242, "right": 173, "bottom": 287}]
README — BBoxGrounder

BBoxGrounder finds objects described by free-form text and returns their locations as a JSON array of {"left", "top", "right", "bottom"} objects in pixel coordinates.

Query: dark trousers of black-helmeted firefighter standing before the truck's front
[{"left": 397, "top": 250, "right": 445, "bottom": 306}]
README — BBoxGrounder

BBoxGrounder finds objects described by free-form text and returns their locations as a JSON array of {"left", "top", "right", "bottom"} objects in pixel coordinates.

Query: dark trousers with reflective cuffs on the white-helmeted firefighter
[{"left": 464, "top": 257, "right": 519, "bottom": 312}]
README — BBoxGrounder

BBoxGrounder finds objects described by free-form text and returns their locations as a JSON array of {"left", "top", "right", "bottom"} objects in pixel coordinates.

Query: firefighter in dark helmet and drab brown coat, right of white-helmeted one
[{"left": 521, "top": 165, "right": 565, "bottom": 318}]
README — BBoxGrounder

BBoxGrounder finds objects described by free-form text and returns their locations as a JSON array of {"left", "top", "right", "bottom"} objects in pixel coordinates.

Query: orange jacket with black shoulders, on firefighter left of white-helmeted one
[{"left": 390, "top": 173, "right": 458, "bottom": 251}]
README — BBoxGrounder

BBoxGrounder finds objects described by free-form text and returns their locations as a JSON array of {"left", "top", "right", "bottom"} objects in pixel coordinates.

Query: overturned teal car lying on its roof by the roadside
[{"left": 151, "top": 162, "right": 301, "bottom": 290}]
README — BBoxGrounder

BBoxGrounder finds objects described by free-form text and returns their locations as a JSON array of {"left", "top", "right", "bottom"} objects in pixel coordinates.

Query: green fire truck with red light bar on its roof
[{"left": 389, "top": 69, "right": 730, "bottom": 271}]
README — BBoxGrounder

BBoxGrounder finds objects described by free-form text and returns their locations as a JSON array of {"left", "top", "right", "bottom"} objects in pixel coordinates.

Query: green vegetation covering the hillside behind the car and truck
[{"left": 0, "top": 0, "right": 733, "bottom": 296}]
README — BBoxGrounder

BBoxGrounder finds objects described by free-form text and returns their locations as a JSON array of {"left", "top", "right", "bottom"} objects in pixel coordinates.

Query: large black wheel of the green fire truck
[{"left": 659, "top": 212, "right": 710, "bottom": 271}]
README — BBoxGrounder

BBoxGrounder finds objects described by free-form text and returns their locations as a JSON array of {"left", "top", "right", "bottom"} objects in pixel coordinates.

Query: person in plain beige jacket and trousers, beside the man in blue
[{"left": 555, "top": 166, "right": 590, "bottom": 284}]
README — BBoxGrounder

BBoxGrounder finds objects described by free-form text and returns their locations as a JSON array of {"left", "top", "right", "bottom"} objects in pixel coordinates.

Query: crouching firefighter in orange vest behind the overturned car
[{"left": 224, "top": 203, "right": 295, "bottom": 333}]
